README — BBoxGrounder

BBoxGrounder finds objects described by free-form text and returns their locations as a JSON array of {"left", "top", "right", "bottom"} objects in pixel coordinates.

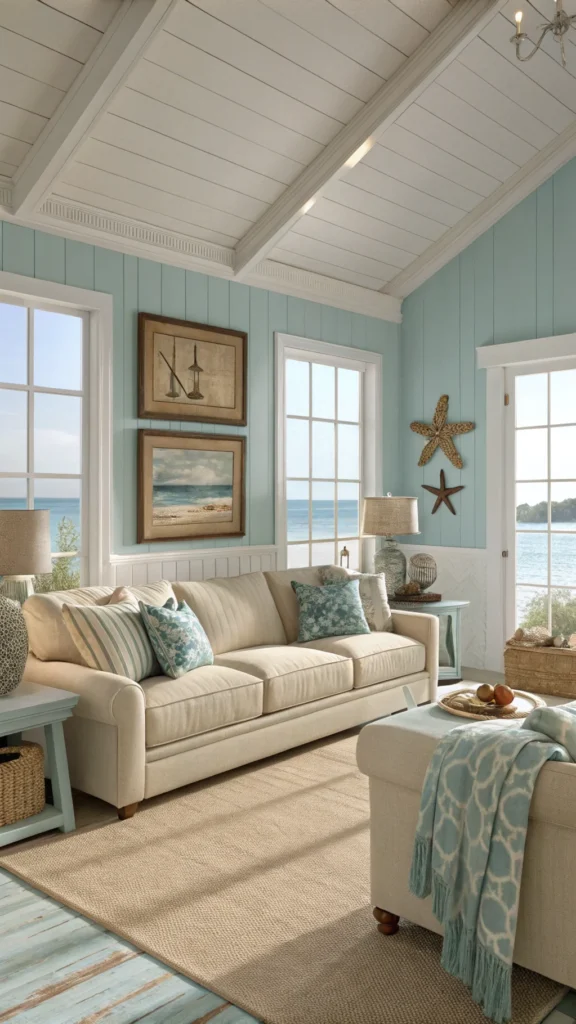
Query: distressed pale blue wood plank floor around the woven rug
[{"left": 0, "top": 869, "right": 576, "bottom": 1024}]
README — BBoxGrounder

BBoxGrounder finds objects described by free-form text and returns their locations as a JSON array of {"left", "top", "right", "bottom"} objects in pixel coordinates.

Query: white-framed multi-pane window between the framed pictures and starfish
[{"left": 277, "top": 335, "right": 381, "bottom": 569}]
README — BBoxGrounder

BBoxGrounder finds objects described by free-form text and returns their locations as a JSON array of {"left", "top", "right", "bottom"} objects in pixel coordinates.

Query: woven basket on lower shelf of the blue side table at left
[{"left": 0, "top": 743, "right": 46, "bottom": 827}]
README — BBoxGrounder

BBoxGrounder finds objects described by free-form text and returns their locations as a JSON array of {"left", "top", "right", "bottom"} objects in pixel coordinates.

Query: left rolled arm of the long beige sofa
[{"left": 25, "top": 655, "right": 146, "bottom": 807}]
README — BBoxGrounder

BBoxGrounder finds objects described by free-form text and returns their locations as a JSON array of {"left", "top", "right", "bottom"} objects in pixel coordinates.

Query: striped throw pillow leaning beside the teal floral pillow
[{"left": 61, "top": 595, "right": 160, "bottom": 683}]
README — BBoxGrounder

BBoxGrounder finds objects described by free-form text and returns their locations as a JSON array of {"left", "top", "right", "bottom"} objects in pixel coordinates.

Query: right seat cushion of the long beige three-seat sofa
[{"left": 298, "top": 633, "right": 426, "bottom": 689}]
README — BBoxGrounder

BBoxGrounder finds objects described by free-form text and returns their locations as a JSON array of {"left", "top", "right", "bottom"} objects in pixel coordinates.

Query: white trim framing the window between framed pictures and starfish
[{"left": 275, "top": 332, "right": 382, "bottom": 568}]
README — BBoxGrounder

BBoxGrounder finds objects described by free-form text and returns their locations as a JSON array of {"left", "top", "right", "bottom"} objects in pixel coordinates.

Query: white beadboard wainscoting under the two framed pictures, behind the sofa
[{"left": 110, "top": 545, "right": 278, "bottom": 587}]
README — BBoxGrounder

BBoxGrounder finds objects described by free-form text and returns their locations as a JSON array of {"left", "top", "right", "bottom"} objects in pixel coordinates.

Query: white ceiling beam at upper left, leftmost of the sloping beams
[{"left": 11, "top": 0, "right": 176, "bottom": 215}]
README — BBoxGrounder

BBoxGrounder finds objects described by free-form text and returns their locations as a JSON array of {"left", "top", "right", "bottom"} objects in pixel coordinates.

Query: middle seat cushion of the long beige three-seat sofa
[{"left": 216, "top": 645, "right": 353, "bottom": 715}]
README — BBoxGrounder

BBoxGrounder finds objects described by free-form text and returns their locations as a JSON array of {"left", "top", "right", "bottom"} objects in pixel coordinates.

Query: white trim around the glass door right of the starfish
[{"left": 476, "top": 334, "right": 576, "bottom": 672}]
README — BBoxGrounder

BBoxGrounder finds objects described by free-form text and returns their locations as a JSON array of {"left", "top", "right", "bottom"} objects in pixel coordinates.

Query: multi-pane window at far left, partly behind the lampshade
[{"left": 0, "top": 297, "right": 88, "bottom": 591}]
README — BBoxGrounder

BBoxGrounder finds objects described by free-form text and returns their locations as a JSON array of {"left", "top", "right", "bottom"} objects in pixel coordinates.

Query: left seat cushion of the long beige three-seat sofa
[{"left": 140, "top": 665, "right": 262, "bottom": 746}]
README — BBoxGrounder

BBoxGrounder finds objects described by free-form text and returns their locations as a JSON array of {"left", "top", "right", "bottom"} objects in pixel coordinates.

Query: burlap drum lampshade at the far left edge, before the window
[{"left": 0, "top": 509, "right": 52, "bottom": 577}]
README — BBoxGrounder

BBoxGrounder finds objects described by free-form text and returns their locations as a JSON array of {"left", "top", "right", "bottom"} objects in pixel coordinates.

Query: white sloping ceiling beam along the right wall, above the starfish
[{"left": 380, "top": 122, "right": 576, "bottom": 299}]
